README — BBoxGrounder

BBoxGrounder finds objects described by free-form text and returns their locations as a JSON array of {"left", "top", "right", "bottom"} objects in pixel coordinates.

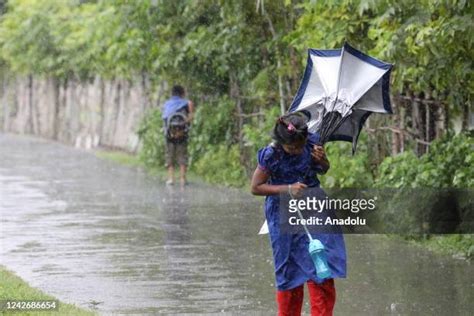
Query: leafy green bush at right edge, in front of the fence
[{"left": 375, "top": 134, "right": 474, "bottom": 242}]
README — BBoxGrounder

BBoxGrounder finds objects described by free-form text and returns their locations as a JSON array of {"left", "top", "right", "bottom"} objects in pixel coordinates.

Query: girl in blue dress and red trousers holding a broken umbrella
[{"left": 251, "top": 113, "right": 346, "bottom": 315}]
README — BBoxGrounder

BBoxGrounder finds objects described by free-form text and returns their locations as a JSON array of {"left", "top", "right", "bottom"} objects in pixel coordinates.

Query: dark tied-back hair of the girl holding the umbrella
[{"left": 272, "top": 112, "right": 309, "bottom": 144}]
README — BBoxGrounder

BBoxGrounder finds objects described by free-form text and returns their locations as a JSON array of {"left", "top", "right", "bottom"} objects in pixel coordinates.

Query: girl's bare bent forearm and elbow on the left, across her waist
[{"left": 251, "top": 167, "right": 306, "bottom": 196}]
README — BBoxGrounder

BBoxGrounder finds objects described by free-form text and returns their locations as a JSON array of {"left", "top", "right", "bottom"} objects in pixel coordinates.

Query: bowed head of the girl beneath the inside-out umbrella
[{"left": 272, "top": 112, "right": 308, "bottom": 155}]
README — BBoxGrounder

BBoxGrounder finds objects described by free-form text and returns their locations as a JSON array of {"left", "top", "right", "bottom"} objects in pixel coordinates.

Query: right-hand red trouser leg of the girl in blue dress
[{"left": 308, "top": 279, "right": 336, "bottom": 316}]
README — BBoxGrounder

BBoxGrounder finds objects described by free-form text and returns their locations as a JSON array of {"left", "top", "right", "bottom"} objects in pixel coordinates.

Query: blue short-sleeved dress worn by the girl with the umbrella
[{"left": 257, "top": 134, "right": 346, "bottom": 290}]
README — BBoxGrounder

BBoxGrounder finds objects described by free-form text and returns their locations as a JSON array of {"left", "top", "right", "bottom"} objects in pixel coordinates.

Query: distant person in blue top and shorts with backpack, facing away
[{"left": 162, "top": 85, "right": 194, "bottom": 186}]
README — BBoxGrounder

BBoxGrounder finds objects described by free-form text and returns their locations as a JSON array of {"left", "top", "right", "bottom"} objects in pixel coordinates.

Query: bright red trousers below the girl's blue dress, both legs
[{"left": 277, "top": 279, "right": 336, "bottom": 316}]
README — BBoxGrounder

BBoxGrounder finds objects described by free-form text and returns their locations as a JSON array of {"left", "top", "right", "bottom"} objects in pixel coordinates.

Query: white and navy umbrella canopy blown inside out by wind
[{"left": 289, "top": 43, "right": 392, "bottom": 153}]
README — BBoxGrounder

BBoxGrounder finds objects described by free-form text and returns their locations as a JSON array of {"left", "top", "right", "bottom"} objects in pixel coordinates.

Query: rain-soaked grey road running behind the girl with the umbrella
[{"left": 0, "top": 134, "right": 474, "bottom": 315}]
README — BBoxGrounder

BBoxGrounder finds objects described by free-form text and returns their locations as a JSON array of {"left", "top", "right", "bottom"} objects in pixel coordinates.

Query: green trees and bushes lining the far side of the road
[{"left": 0, "top": 0, "right": 474, "bottom": 256}]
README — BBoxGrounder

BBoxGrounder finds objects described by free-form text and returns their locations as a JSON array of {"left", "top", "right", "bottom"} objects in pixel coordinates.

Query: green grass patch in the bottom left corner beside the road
[{"left": 0, "top": 266, "right": 97, "bottom": 316}]
